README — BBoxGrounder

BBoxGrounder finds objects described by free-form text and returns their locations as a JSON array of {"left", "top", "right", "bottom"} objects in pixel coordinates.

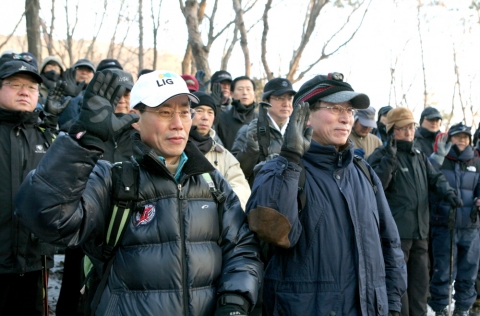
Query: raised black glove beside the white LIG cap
[{"left": 69, "top": 71, "right": 139, "bottom": 151}]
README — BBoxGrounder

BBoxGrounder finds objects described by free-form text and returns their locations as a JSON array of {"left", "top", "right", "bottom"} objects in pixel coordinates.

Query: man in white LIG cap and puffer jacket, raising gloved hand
[{"left": 16, "top": 71, "right": 263, "bottom": 316}]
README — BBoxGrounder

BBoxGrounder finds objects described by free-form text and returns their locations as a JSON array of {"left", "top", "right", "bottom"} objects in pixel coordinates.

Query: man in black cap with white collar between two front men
[{"left": 232, "top": 78, "right": 296, "bottom": 184}]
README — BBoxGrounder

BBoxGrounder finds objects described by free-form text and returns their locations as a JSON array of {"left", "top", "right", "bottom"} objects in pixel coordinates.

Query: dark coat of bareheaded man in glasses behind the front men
[{"left": 215, "top": 100, "right": 258, "bottom": 151}]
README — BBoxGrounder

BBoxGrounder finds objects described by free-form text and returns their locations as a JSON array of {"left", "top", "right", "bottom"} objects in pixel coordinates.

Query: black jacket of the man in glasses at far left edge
[{"left": 0, "top": 109, "right": 58, "bottom": 274}]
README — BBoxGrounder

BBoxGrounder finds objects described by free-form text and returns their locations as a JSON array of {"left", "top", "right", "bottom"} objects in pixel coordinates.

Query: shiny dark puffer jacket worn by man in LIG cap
[{"left": 16, "top": 134, "right": 263, "bottom": 316}]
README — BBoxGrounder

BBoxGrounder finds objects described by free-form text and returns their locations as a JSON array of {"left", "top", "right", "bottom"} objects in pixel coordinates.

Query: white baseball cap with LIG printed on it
[{"left": 130, "top": 70, "right": 199, "bottom": 109}]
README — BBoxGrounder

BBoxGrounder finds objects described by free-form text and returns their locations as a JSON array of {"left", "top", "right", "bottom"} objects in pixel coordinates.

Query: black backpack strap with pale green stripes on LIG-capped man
[{"left": 91, "top": 161, "right": 138, "bottom": 316}]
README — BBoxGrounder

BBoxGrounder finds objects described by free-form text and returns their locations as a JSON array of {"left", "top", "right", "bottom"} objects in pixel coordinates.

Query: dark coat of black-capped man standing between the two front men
[{"left": 232, "top": 117, "right": 283, "bottom": 179}]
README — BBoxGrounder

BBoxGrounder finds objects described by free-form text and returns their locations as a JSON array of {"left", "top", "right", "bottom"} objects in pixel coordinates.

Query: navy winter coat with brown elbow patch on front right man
[{"left": 247, "top": 141, "right": 407, "bottom": 316}]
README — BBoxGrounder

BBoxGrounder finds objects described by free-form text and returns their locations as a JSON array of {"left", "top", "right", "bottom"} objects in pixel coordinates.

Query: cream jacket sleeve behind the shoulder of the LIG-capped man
[{"left": 224, "top": 149, "right": 251, "bottom": 211}]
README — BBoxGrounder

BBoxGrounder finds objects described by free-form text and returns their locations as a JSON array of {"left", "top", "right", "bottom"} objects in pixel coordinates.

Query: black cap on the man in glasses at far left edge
[{"left": 0, "top": 52, "right": 43, "bottom": 83}]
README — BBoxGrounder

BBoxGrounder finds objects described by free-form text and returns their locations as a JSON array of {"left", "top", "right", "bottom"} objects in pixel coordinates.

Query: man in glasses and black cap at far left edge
[{"left": 0, "top": 53, "right": 56, "bottom": 315}]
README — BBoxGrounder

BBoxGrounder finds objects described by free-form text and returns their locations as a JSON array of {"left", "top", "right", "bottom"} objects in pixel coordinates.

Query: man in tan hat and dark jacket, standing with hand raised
[{"left": 368, "top": 107, "right": 462, "bottom": 315}]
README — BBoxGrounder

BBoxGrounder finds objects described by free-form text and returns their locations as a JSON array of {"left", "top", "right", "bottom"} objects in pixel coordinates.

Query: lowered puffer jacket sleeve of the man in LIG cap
[{"left": 215, "top": 172, "right": 263, "bottom": 311}]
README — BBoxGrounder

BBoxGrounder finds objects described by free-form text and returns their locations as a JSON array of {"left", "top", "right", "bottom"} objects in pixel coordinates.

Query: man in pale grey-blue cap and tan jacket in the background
[{"left": 348, "top": 106, "right": 382, "bottom": 159}]
